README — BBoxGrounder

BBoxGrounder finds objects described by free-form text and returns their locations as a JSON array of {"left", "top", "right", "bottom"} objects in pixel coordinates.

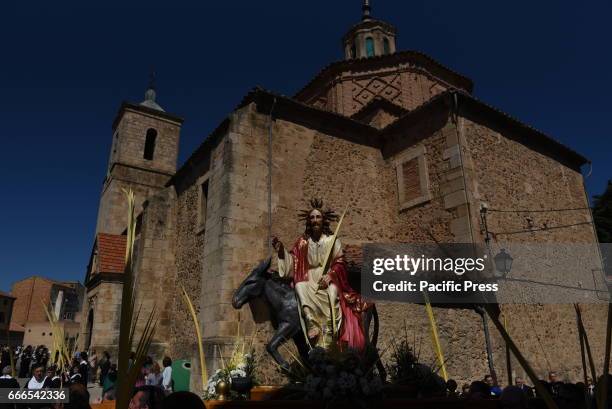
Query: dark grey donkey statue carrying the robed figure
[{"left": 232, "top": 258, "right": 386, "bottom": 376}]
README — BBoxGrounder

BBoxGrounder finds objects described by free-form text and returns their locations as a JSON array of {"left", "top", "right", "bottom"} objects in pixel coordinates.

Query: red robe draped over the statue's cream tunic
[{"left": 291, "top": 237, "right": 368, "bottom": 351}]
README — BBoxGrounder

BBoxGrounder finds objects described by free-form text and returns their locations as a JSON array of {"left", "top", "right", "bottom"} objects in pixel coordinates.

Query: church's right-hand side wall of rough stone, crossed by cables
[{"left": 459, "top": 118, "right": 607, "bottom": 382}]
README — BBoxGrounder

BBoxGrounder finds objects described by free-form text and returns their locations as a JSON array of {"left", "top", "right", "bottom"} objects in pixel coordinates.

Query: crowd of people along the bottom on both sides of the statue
[{"left": 0, "top": 345, "right": 612, "bottom": 409}]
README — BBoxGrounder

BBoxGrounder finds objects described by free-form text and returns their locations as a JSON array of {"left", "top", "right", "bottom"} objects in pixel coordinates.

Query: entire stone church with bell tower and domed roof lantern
[{"left": 81, "top": 0, "right": 606, "bottom": 385}]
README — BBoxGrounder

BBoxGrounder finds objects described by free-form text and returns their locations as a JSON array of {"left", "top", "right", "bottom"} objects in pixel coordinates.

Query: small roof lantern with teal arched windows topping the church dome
[{"left": 342, "top": 0, "right": 397, "bottom": 60}]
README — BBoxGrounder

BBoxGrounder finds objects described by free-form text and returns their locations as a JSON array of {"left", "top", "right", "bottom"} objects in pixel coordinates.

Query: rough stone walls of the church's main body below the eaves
[{"left": 163, "top": 92, "right": 603, "bottom": 385}]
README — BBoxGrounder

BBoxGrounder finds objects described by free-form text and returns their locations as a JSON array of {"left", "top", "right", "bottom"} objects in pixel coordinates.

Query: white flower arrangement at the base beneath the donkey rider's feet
[{"left": 287, "top": 347, "right": 383, "bottom": 401}]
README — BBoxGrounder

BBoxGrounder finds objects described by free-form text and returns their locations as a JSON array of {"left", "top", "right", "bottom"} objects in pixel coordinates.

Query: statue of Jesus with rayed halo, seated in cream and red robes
[{"left": 272, "top": 199, "right": 367, "bottom": 351}]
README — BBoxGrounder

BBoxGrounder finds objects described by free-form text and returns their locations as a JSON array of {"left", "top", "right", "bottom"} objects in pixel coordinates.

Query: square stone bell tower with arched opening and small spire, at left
[{"left": 96, "top": 78, "right": 183, "bottom": 234}]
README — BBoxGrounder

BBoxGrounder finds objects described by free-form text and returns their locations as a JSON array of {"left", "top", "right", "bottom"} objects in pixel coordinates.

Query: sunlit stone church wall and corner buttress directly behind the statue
[{"left": 192, "top": 106, "right": 486, "bottom": 382}]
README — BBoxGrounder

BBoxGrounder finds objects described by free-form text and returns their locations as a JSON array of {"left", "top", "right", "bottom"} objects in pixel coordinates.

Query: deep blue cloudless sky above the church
[{"left": 0, "top": 0, "right": 612, "bottom": 291}]
